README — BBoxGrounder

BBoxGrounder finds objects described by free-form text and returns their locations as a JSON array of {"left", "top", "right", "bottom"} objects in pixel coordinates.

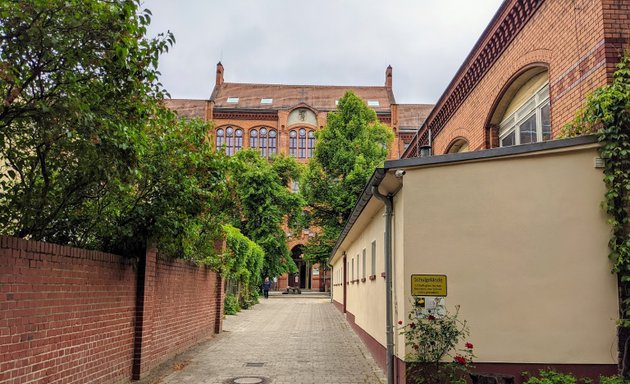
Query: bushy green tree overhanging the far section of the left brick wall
[{"left": 94, "top": 109, "right": 227, "bottom": 260}]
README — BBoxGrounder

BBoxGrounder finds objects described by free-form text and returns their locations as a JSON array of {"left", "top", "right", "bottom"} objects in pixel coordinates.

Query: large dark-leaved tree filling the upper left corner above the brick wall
[{"left": 0, "top": 0, "right": 174, "bottom": 245}]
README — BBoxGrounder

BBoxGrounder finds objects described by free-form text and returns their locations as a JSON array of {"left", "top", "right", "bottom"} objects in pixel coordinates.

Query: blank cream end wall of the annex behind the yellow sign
[{"left": 396, "top": 145, "right": 617, "bottom": 364}]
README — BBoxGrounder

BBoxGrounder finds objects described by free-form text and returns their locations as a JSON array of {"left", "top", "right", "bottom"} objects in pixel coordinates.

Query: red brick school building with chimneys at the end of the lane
[{"left": 166, "top": 63, "right": 433, "bottom": 289}]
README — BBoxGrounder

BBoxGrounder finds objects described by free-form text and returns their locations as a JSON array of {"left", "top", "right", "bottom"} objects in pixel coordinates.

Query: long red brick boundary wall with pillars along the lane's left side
[{"left": 0, "top": 236, "right": 223, "bottom": 384}]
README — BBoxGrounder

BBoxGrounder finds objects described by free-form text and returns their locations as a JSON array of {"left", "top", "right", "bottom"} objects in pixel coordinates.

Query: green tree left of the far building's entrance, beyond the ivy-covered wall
[{"left": 228, "top": 150, "right": 304, "bottom": 276}]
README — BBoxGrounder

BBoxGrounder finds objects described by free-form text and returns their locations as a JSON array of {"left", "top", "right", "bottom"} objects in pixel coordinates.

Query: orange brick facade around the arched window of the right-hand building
[{"left": 424, "top": 0, "right": 630, "bottom": 154}]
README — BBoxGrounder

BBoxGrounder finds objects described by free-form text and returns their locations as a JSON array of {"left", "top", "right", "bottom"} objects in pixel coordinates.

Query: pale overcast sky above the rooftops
[{"left": 143, "top": 0, "right": 502, "bottom": 103}]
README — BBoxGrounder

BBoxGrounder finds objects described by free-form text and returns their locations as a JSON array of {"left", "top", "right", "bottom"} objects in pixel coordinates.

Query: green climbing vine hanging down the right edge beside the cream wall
[{"left": 564, "top": 56, "right": 630, "bottom": 320}]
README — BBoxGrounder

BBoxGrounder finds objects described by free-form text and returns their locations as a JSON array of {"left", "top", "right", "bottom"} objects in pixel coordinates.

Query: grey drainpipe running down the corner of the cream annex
[{"left": 372, "top": 185, "right": 394, "bottom": 384}]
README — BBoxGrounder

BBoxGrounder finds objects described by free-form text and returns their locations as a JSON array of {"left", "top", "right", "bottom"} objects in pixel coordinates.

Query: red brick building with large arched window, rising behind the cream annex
[{"left": 402, "top": 0, "right": 630, "bottom": 158}]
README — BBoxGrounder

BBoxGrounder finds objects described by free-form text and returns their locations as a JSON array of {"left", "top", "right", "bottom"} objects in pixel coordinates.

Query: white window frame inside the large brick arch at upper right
[{"left": 499, "top": 82, "right": 550, "bottom": 147}]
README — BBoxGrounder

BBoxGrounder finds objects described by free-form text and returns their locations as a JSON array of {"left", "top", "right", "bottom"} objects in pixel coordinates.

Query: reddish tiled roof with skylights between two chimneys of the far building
[{"left": 210, "top": 83, "right": 395, "bottom": 112}]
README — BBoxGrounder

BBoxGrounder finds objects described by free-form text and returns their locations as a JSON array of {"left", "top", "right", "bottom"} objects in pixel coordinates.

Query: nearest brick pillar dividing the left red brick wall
[{"left": 132, "top": 244, "right": 157, "bottom": 380}]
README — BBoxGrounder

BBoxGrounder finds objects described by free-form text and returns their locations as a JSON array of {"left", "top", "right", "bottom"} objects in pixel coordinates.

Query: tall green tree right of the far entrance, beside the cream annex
[{"left": 302, "top": 92, "right": 394, "bottom": 266}]
